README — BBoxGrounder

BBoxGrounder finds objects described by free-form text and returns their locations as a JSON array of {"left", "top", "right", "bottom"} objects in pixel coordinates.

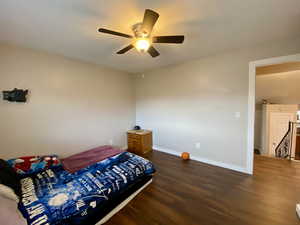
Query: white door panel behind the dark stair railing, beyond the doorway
[{"left": 269, "top": 112, "right": 295, "bottom": 156}]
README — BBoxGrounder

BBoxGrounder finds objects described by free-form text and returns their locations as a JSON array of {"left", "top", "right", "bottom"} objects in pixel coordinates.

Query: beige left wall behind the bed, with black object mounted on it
[{"left": 0, "top": 45, "right": 135, "bottom": 158}]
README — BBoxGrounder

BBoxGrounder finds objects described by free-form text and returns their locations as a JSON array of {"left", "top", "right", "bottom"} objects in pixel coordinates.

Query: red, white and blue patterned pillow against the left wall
[{"left": 7, "top": 155, "right": 61, "bottom": 175}]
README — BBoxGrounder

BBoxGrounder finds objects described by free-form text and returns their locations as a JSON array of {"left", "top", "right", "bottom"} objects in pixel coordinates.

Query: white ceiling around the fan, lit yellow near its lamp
[{"left": 0, "top": 0, "right": 300, "bottom": 73}]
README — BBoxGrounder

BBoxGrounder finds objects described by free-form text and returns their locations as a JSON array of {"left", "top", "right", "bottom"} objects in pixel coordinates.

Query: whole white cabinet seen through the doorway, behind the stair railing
[{"left": 262, "top": 104, "right": 298, "bottom": 156}]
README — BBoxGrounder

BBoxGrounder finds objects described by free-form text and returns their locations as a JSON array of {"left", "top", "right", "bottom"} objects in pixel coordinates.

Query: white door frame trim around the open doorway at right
[{"left": 246, "top": 54, "right": 300, "bottom": 174}]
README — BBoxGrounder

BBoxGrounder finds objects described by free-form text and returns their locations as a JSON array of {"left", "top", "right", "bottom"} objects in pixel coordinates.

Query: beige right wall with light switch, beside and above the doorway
[{"left": 136, "top": 39, "right": 300, "bottom": 170}]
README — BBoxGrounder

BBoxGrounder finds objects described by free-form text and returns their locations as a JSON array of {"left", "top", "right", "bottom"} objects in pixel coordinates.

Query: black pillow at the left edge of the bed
[{"left": 0, "top": 159, "right": 22, "bottom": 197}]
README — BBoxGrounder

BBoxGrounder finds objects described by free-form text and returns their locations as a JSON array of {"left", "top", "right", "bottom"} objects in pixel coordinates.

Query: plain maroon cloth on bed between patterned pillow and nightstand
[{"left": 61, "top": 145, "right": 124, "bottom": 173}]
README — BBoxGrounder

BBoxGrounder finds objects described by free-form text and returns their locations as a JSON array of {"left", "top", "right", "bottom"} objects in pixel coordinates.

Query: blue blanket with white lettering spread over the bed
[{"left": 19, "top": 152, "right": 155, "bottom": 225}]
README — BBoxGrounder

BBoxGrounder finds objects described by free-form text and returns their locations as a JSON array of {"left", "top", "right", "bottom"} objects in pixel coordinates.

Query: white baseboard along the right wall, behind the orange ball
[{"left": 153, "top": 146, "right": 249, "bottom": 174}]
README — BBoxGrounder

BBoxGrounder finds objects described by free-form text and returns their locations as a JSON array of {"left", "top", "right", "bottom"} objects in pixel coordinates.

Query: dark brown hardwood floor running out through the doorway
[{"left": 106, "top": 151, "right": 300, "bottom": 225}]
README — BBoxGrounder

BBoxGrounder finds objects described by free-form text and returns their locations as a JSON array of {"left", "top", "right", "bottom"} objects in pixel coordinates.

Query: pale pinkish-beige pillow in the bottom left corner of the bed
[{"left": 0, "top": 196, "right": 27, "bottom": 225}]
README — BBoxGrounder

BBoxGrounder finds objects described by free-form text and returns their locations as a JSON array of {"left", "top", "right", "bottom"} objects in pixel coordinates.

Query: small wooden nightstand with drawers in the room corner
[{"left": 127, "top": 130, "right": 152, "bottom": 155}]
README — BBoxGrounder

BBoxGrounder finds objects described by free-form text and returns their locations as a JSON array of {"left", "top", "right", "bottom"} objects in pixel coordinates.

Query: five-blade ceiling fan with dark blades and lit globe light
[{"left": 98, "top": 9, "right": 184, "bottom": 57}]
